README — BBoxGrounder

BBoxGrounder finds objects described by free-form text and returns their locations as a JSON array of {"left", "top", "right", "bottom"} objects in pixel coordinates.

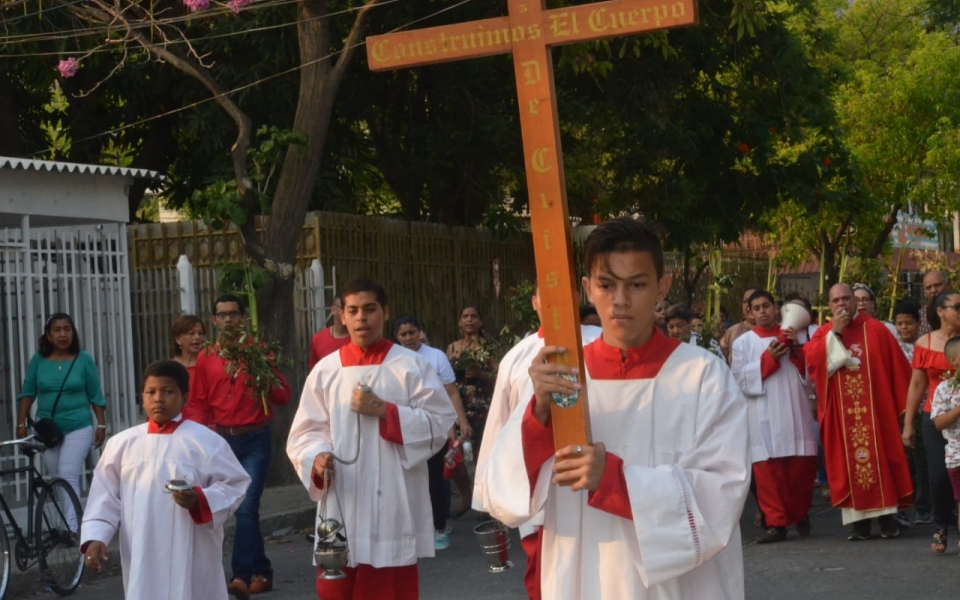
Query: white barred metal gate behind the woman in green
[{"left": 0, "top": 216, "right": 143, "bottom": 495}]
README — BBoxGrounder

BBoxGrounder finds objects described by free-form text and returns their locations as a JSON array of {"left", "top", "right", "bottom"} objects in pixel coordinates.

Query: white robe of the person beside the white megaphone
[{"left": 730, "top": 328, "right": 817, "bottom": 462}]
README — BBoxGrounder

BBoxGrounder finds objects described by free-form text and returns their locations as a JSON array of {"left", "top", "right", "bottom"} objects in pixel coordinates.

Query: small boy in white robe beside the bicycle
[{"left": 80, "top": 360, "right": 250, "bottom": 600}]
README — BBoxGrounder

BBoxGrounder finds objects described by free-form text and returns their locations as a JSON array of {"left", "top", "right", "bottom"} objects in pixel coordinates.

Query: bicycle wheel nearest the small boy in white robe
[{"left": 34, "top": 478, "right": 83, "bottom": 596}]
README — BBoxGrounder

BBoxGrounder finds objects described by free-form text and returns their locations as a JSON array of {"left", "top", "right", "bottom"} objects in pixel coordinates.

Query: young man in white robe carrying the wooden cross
[{"left": 483, "top": 218, "right": 750, "bottom": 600}]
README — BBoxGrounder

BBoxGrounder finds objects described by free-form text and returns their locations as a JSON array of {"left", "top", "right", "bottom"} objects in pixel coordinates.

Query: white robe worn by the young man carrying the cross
[{"left": 484, "top": 340, "right": 749, "bottom": 600}]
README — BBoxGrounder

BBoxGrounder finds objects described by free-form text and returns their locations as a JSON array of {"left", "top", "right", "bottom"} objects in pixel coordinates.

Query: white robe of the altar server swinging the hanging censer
[{"left": 287, "top": 344, "right": 456, "bottom": 568}]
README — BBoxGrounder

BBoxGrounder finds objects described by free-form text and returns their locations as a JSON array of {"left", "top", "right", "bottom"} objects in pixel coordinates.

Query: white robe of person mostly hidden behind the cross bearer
[{"left": 472, "top": 325, "right": 603, "bottom": 520}]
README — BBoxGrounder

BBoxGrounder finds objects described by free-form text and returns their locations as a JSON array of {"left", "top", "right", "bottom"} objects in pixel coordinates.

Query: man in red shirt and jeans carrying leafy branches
[{"left": 183, "top": 294, "right": 290, "bottom": 596}]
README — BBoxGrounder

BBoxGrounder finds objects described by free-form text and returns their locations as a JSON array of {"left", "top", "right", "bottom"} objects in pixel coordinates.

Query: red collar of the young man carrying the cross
[{"left": 583, "top": 327, "right": 681, "bottom": 379}]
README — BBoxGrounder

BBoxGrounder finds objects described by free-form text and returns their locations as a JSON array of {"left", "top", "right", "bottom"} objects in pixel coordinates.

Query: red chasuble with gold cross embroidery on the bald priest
[{"left": 804, "top": 312, "right": 913, "bottom": 511}]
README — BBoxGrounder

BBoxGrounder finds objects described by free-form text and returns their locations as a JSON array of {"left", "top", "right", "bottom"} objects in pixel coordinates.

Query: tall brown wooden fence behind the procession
[{"left": 128, "top": 213, "right": 767, "bottom": 380}]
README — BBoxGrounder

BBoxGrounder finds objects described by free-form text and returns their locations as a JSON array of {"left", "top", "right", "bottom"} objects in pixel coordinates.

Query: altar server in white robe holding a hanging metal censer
[{"left": 287, "top": 279, "right": 456, "bottom": 600}]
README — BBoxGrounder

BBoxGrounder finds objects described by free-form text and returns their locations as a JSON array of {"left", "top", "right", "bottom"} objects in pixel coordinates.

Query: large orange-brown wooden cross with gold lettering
[{"left": 367, "top": 0, "right": 697, "bottom": 448}]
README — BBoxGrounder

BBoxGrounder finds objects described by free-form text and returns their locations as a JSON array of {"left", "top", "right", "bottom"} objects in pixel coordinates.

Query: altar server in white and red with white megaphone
[{"left": 730, "top": 290, "right": 817, "bottom": 544}]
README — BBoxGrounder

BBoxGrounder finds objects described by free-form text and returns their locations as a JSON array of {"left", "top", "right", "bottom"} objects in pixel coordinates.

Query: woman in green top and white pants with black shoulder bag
[{"left": 17, "top": 313, "right": 107, "bottom": 531}]
